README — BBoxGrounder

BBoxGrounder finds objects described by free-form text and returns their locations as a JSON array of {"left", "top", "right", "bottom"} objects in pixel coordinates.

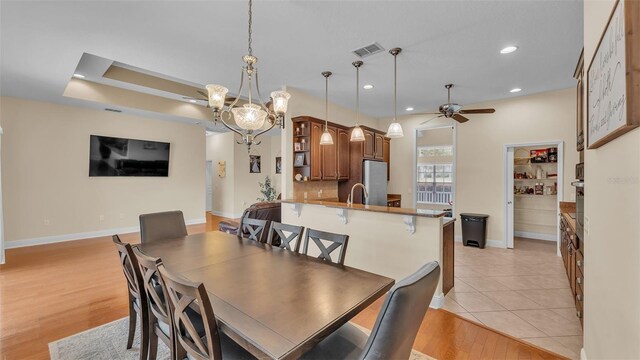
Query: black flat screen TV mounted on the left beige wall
[{"left": 89, "top": 135, "right": 170, "bottom": 177}]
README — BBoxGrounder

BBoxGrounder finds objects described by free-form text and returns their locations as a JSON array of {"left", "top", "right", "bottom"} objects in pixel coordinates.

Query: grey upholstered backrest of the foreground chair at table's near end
[{"left": 360, "top": 261, "right": 440, "bottom": 360}]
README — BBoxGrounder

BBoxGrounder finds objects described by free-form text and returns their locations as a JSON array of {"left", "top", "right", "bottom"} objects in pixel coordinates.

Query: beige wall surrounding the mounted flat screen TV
[{"left": 0, "top": 97, "right": 205, "bottom": 242}]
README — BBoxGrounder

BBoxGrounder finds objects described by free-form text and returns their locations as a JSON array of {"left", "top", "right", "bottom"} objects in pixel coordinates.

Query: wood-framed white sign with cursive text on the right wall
[{"left": 587, "top": 0, "right": 640, "bottom": 149}]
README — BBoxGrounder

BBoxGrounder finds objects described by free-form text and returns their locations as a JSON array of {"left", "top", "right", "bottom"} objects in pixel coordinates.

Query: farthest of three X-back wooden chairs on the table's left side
[{"left": 112, "top": 235, "right": 149, "bottom": 360}]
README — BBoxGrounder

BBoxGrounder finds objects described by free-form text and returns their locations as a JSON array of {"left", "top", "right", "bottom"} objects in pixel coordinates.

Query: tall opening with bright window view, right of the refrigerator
[{"left": 413, "top": 124, "right": 456, "bottom": 217}]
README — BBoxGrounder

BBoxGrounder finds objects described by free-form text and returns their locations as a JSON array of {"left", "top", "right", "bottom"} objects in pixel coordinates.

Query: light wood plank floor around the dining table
[{"left": 0, "top": 214, "right": 558, "bottom": 360}]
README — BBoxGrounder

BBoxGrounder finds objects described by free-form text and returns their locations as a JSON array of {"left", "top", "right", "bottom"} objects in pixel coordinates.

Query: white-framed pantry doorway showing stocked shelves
[{"left": 504, "top": 141, "right": 564, "bottom": 254}]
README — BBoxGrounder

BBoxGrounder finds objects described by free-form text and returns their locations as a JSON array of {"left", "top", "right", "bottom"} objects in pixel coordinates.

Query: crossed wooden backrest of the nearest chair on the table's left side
[{"left": 158, "top": 264, "right": 222, "bottom": 360}]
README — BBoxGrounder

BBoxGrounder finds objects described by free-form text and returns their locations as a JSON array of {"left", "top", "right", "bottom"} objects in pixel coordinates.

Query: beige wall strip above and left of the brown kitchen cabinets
[{"left": 281, "top": 88, "right": 386, "bottom": 198}]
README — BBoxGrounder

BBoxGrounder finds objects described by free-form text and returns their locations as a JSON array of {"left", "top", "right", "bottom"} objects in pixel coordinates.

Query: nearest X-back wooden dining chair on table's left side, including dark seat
[{"left": 158, "top": 264, "right": 255, "bottom": 360}]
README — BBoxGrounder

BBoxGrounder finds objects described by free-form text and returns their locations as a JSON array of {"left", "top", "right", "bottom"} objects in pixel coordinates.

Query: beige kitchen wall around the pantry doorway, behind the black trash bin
[{"left": 379, "top": 88, "right": 578, "bottom": 242}]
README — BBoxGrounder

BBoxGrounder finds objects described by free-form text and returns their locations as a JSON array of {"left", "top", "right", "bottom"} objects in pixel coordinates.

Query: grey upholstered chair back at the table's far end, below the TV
[{"left": 140, "top": 210, "right": 187, "bottom": 243}]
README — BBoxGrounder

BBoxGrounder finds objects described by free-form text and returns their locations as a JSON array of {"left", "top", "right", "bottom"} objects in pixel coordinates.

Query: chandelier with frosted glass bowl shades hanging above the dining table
[{"left": 206, "top": 0, "right": 291, "bottom": 151}]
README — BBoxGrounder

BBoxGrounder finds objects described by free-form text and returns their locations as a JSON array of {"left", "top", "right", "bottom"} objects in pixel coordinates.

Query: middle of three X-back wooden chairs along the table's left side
[{"left": 133, "top": 247, "right": 174, "bottom": 360}]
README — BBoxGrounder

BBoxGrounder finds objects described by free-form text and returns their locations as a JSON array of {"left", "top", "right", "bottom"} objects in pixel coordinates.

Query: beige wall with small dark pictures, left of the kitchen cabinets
[{"left": 207, "top": 132, "right": 282, "bottom": 218}]
